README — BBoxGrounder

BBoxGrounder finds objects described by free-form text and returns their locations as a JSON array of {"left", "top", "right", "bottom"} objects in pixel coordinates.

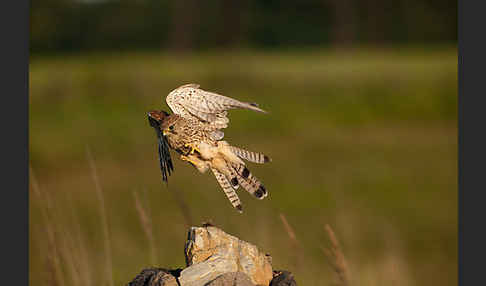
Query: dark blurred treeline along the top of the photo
[{"left": 30, "top": 0, "right": 457, "bottom": 54}]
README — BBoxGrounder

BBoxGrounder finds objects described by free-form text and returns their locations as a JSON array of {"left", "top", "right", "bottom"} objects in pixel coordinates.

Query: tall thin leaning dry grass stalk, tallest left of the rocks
[{"left": 86, "top": 146, "right": 113, "bottom": 286}]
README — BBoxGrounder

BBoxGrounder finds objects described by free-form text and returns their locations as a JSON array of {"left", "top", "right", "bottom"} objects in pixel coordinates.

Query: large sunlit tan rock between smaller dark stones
[{"left": 179, "top": 226, "right": 273, "bottom": 286}]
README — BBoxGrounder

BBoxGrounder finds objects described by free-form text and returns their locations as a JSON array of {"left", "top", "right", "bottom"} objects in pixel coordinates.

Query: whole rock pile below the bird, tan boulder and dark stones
[{"left": 127, "top": 226, "right": 297, "bottom": 286}]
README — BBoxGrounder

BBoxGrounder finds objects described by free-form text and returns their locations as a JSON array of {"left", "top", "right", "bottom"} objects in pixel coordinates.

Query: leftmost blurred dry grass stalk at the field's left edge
[{"left": 30, "top": 166, "right": 66, "bottom": 285}]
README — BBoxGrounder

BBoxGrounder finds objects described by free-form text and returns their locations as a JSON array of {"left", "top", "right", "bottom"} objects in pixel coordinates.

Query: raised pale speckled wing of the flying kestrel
[{"left": 165, "top": 83, "right": 266, "bottom": 140}]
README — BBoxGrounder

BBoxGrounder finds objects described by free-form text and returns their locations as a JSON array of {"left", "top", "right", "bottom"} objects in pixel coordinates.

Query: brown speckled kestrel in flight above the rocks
[{"left": 148, "top": 84, "right": 270, "bottom": 212}]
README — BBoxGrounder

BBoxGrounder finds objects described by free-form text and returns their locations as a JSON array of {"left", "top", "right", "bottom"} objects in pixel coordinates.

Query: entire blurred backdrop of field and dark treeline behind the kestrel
[{"left": 29, "top": 0, "right": 457, "bottom": 286}]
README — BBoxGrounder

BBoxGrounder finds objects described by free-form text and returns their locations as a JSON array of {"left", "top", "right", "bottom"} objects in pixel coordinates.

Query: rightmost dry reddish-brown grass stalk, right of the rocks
[{"left": 322, "top": 224, "right": 350, "bottom": 285}]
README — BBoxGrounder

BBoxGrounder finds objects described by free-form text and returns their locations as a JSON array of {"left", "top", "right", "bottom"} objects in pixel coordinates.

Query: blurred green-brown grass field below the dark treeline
[{"left": 29, "top": 47, "right": 457, "bottom": 286}]
